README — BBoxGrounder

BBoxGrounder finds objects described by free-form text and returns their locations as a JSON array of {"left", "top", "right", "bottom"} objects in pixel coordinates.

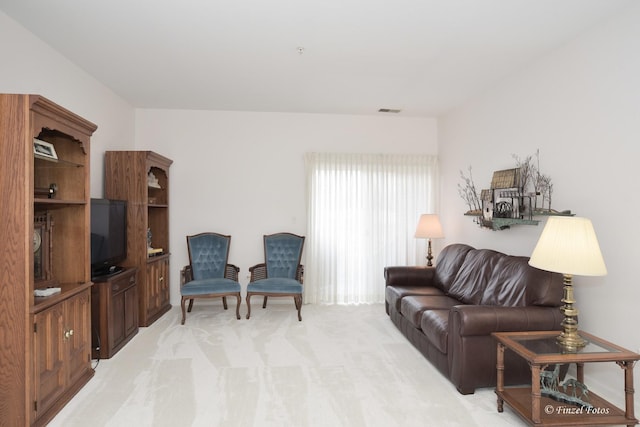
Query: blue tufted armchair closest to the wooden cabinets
[{"left": 180, "top": 233, "right": 242, "bottom": 325}]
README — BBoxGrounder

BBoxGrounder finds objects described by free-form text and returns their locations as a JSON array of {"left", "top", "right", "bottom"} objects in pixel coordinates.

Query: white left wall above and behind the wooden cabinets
[{"left": 0, "top": 11, "right": 135, "bottom": 197}]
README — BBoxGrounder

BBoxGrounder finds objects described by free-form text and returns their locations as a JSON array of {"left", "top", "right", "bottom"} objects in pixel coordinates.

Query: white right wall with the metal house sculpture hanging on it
[{"left": 439, "top": 2, "right": 640, "bottom": 407}]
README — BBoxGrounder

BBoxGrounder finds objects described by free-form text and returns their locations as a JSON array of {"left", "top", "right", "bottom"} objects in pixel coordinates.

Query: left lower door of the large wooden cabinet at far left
[{"left": 33, "top": 304, "right": 67, "bottom": 418}]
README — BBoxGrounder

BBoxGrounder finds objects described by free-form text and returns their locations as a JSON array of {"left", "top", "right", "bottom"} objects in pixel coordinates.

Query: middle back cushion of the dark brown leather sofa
[{"left": 447, "top": 249, "right": 506, "bottom": 304}]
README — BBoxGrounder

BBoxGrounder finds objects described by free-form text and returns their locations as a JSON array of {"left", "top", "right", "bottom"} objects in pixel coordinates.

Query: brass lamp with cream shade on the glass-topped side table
[{"left": 529, "top": 216, "right": 607, "bottom": 352}]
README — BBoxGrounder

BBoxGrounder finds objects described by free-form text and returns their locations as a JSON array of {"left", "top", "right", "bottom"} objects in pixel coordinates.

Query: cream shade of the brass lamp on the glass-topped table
[{"left": 529, "top": 216, "right": 607, "bottom": 276}]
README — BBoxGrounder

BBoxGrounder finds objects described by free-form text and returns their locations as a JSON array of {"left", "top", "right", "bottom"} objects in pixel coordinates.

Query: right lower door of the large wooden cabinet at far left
[{"left": 64, "top": 289, "right": 91, "bottom": 384}]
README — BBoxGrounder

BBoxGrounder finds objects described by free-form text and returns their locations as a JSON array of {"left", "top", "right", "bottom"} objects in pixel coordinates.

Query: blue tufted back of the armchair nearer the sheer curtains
[{"left": 264, "top": 233, "right": 304, "bottom": 279}]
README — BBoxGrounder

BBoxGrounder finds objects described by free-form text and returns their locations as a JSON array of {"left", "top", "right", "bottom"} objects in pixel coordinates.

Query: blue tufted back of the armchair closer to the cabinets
[{"left": 187, "top": 233, "right": 231, "bottom": 280}]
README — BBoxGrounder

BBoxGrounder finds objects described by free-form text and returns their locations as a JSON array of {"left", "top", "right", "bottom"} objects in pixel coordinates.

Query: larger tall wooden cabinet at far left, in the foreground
[{"left": 0, "top": 94, "right": 96, "bottom": 426}]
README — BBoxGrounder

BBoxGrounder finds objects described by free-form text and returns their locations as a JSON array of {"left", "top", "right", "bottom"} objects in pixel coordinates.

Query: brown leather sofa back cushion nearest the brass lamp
[{"left": 481, "top": 255, "right": 563, "bottom": 307}]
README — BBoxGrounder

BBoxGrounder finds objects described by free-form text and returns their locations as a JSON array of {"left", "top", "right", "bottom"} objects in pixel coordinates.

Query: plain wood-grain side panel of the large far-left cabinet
[{"left": 0, "top": 95, "right": 33, "bottom": 425}]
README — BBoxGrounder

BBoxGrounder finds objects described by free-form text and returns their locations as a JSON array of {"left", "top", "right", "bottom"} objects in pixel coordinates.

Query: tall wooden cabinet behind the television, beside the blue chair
[{"left": 104, "top": 151, "right": 173, "bottom": 326}]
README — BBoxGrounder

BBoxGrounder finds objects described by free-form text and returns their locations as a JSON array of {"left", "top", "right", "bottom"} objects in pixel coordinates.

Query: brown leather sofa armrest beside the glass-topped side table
[{"left": 449, "top": 305, "right": 563, "bottom": 336}]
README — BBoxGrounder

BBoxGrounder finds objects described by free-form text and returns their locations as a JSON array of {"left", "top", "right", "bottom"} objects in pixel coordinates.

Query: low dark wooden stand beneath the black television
[{"left": 91, "top": 267, "right": 138, "bottom": 359}]
